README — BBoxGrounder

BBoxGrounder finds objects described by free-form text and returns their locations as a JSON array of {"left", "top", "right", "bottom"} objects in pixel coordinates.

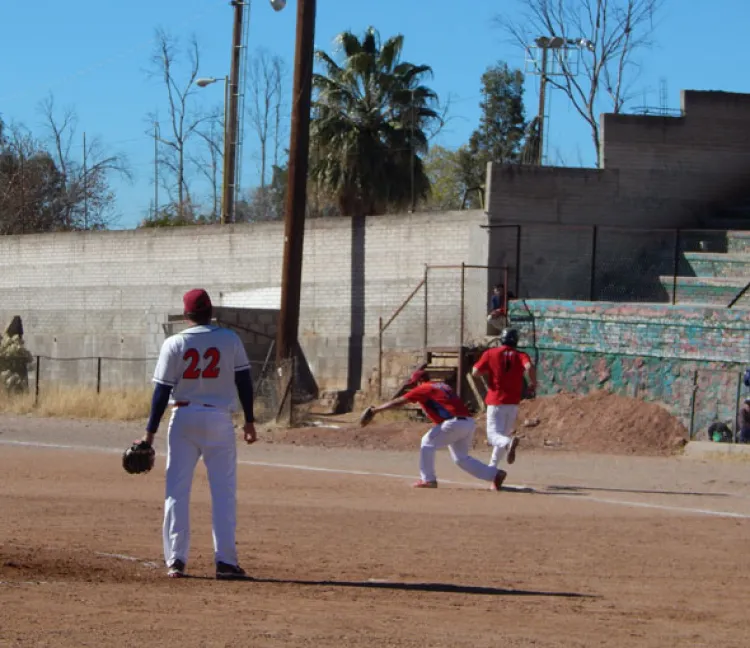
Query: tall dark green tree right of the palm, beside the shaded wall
[{"left": 459, "top": 62, "right": 526, "bottom": 207}]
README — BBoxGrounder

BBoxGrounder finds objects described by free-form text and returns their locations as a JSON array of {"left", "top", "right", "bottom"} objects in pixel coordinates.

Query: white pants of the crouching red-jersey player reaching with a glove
[{"left": 419, "top": 418, "right": 497, "bottom": 481}]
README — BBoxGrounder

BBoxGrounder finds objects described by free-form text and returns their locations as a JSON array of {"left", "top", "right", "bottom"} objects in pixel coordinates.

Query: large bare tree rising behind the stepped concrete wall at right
[{"left": 497, "top": 0, "right": 663, "bottom": 166}]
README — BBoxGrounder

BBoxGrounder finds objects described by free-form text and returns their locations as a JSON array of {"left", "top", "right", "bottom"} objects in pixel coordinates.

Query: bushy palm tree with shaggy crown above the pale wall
[{"left": 311, "top": 27, "right": 441, "bottom": 216}]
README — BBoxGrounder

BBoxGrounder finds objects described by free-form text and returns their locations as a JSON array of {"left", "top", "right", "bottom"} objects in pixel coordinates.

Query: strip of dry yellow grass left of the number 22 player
[{"left": 0, "top": 387, "right": 152, "bottom": 421}]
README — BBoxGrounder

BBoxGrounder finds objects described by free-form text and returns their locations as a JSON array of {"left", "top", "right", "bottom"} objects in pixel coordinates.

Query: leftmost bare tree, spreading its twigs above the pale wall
[{"left": 39, "top": 95, "right": 132, "bottom": 229}]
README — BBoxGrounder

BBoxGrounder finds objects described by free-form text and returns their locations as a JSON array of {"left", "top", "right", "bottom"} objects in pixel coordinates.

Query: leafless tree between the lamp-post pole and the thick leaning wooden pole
[{"left": 247, "top": 48, "right": 287, "bottom": 191}]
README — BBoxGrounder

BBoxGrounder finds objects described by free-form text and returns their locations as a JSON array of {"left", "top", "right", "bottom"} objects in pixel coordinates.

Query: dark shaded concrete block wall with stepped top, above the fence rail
[{"left": 487, "top": 90, "right": 750, "bottom": 228}]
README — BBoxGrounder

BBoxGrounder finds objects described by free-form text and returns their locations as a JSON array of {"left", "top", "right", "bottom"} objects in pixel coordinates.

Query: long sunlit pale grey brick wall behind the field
[{"left": 0, "top": 211, "right": 488, "bottom": 389}]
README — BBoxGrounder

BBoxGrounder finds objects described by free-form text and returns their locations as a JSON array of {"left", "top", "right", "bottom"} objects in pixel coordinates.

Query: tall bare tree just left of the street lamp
[{"left": 149, "top": 29, "right": 207, "bottom": 218}]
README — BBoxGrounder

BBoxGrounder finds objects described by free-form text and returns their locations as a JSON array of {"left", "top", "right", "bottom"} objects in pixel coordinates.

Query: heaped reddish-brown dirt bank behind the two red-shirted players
[{"left": 274, "top": 392, "right": 688, "bottom": 456}]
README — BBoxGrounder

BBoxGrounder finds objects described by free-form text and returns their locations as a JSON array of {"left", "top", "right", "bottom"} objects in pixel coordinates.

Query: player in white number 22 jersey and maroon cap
[{"left": 143, "top": 289, "right": 256, "bottom": 579}]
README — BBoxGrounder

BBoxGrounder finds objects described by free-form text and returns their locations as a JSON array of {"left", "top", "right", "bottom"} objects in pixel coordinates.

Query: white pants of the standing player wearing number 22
[{"left": 164, "top": 406, "right": 237, "bottom": 565}]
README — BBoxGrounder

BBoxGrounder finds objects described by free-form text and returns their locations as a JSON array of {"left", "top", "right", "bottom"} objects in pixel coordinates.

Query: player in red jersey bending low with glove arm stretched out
[{"left": 373, "top": 369, "right": 506, "bottom": 490}]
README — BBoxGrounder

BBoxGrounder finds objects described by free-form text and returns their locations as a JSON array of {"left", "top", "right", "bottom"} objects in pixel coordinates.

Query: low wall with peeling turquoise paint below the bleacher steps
[{"left": 511, "top": 300, "right": 750, "bottom": 436}]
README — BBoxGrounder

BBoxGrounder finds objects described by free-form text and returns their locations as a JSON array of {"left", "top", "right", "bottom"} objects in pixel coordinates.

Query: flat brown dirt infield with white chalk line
[{"left": 0, "top": 417, "right": 750, "bottom": 648}]
